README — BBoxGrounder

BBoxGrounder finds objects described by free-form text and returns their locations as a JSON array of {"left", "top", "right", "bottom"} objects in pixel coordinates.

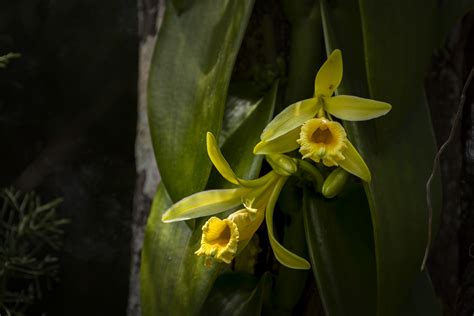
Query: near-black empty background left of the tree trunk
[{"left": 0, "top": 0, "right": 138, "bottom": 315}]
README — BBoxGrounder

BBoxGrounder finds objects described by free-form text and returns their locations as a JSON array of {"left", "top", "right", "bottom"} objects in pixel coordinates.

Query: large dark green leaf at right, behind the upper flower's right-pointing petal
[{"left": 322, "top": 0, "right": 466, "bottom": 315}]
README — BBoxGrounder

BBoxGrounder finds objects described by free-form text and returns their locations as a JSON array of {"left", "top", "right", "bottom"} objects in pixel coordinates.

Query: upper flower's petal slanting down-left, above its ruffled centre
[{"left": 260, "top": 98, "right": 321, "bottom": 141}]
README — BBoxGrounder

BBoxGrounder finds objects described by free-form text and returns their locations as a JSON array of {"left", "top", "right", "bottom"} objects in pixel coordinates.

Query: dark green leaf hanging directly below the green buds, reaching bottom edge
[{"left": 303, "top": 183, "right": 376, "bottom": 316}]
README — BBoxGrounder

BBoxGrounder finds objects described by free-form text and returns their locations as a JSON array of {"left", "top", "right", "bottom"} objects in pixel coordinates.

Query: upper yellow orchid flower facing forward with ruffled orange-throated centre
[{"left": 254, "top": 49, "right": 392, "bottom": 182}]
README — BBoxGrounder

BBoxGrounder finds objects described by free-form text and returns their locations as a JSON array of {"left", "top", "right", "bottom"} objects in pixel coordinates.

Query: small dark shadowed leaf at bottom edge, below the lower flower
[{"left": 201, "top": 272, "right": 272, "bottom": 316}]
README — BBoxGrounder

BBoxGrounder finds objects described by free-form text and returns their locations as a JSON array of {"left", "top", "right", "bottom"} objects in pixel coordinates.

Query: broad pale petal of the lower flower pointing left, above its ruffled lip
[{"left": 161, "top": 188, "right": 249, "bottom": 223}]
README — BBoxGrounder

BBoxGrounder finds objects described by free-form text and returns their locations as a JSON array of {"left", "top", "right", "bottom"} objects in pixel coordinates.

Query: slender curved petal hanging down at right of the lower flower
[{"left": 265, "top": 177, "right": 311, "bottom": 270}]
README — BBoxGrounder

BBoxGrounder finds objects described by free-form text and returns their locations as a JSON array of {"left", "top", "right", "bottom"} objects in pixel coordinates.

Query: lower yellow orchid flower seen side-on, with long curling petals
[{"left": 162, "top": 133, "right": 310, "bottom": 269}]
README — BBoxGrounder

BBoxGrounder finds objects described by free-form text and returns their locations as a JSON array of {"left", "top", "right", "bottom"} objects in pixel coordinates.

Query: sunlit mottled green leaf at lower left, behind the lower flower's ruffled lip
[{"left": 140, "top": 184, "right": 225, "bottom": 316}]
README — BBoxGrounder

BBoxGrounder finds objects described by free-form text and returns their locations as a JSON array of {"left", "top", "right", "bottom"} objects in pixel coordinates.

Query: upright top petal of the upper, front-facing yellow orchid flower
[{"left": 314, "top": 49, "right": 342, "bottom": 97}]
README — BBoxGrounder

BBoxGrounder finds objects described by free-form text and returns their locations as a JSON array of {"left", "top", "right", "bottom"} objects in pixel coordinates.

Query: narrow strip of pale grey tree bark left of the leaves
[{"left": 127, "top": 0, "right": 165, "bottom": 316}]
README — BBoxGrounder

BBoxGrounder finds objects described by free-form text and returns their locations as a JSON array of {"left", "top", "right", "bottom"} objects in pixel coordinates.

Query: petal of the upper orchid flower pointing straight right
[{"left": 324, "top": 95, "right": 392, "bottom": 121}]
